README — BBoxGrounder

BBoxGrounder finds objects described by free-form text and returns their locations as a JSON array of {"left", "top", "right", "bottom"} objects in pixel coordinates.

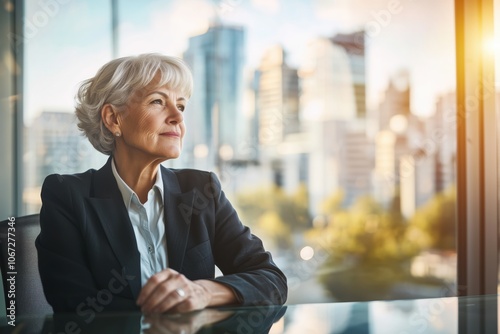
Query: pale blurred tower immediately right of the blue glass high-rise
[{"left": 256, "top": 46, "right": 299, "bottom": 146}]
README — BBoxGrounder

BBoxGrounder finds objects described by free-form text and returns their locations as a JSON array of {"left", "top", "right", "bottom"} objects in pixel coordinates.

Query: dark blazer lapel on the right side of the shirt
[{"left": 160, "top": 166, "right": 196, "bottom": 271}]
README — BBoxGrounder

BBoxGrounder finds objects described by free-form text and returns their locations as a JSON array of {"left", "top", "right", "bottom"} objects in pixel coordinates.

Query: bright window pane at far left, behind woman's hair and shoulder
[{"left": 23, "top": 1, "right": 112, "bottom": 213}]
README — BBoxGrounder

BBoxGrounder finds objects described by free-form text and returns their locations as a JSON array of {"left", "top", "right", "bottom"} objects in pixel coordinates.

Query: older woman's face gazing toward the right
[{"left": 117, "top": 84, "right": 187, "bottom": 161}]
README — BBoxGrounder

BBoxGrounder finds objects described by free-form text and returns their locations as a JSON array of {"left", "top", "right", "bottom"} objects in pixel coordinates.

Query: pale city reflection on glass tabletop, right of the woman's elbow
[{"left": 280, "top": 298, "right": 458, "bottom": 334}]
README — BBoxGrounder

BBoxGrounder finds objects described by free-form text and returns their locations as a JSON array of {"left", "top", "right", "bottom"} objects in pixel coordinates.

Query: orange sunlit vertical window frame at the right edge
[{"left": 455, "top": 0, "right": 498, "bottom": 296}]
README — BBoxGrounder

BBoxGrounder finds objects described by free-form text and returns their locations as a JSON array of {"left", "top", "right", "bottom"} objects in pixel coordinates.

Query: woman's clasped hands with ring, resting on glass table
[{"left": 137, "top": 269, "right": 236, "bottom": 313}]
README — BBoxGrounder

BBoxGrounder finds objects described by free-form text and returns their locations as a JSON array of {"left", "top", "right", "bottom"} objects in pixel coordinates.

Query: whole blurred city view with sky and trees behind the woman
[{"left": 19, "top": 0, "right": 500, "bottom": 303}]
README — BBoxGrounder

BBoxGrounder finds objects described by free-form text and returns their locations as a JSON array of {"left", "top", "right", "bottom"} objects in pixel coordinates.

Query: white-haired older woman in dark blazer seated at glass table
[{"left": 36, "top": 54, "right": 287, "bottom": 314}]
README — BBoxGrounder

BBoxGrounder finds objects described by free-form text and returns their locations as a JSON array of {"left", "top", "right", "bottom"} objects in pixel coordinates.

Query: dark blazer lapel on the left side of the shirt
[{"left": 88, "top": 158, "right": 141, "bottom": 298}]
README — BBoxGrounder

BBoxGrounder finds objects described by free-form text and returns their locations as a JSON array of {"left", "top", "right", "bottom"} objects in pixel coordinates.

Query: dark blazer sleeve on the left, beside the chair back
[{"left": 35, "top": 175, "right": 137, "bottom": 312}]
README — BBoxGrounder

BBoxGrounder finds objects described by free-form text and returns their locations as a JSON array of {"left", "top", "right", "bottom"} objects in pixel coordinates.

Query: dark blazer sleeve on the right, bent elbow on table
[{"left": 206, "top": 173, "right": 288, "bottom": 306}]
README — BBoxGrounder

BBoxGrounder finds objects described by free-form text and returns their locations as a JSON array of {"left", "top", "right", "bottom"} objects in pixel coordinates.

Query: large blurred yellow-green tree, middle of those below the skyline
[{"left": 316, "top": 193, "right": 424, "bottom": 301}]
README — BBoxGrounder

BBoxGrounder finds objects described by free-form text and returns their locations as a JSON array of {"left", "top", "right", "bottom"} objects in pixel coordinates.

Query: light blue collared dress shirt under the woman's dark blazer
[{"left": 111, "top": 160, "right": 167, "bottom": 286}]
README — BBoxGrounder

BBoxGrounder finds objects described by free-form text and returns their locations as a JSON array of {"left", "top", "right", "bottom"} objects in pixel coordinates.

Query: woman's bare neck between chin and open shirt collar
[{"left": 113, "top": 151, "right": 161, "bottom": 204}]
